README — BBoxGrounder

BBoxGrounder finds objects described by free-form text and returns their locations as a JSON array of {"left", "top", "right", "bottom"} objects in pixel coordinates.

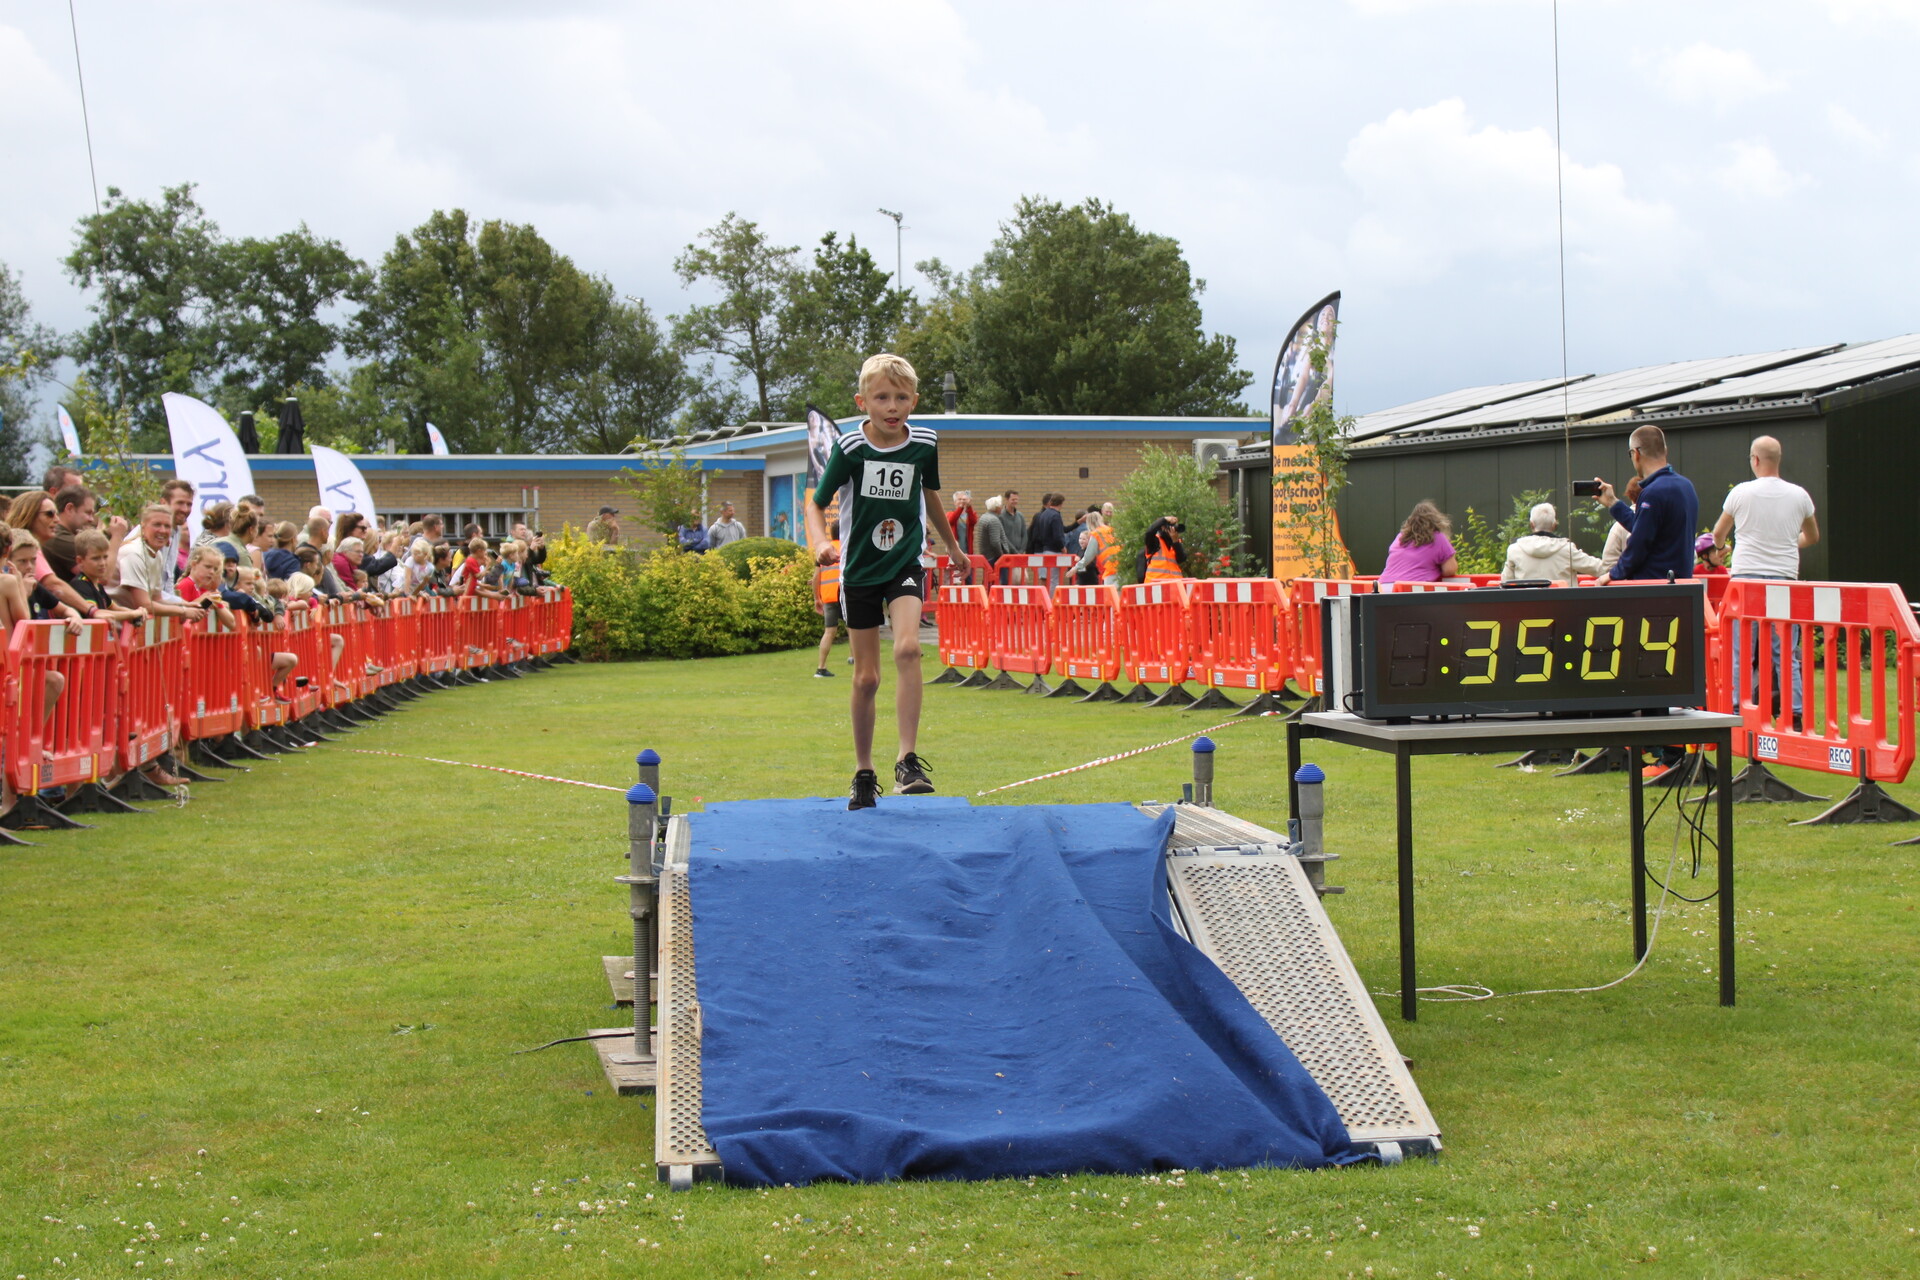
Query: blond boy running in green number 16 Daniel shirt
[{"left": 806, "top": 355, "right": 970, "bottom": 810}]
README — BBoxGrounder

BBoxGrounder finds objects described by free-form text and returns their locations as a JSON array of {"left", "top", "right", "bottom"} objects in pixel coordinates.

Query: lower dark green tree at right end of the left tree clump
[{"left": 561, "top": 280, "right": 687, "bottom": 453}]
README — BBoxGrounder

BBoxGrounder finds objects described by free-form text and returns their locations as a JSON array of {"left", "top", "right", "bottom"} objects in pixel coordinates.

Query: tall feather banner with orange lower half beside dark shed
[{"left": 1273, "top": 290, "right": 1354, "bottom": 581}]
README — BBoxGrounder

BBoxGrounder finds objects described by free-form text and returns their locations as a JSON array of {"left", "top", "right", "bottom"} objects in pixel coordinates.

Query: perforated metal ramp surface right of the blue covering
[{"left": 1140, "top": 804, "right": 1440, "bottom": 1150}]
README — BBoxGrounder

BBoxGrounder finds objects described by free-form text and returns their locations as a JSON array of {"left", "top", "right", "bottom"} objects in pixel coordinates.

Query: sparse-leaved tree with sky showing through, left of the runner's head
[{"left": 674, "top": 213, "right": 801, "bottom": 422}]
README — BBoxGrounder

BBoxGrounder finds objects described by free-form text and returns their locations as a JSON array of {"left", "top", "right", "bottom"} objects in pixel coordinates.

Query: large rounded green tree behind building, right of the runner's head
[{"left": 900, "top": 198, "right": 1252, "bottom": 415}]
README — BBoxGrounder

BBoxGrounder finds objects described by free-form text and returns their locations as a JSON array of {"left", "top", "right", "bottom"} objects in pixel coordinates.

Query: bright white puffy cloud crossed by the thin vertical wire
[{"left": 1344, "top": 98, "right": 1678, "bottom": 284}]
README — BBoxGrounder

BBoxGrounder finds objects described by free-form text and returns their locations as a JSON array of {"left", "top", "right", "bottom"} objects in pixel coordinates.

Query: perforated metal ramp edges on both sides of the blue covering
[{"left": 653, "top": 804, "right": 1440, "bottom": 1188}]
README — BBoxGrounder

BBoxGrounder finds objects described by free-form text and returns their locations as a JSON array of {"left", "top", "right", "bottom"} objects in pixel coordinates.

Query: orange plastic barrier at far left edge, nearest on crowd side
[{"left": 6, "top": 622, "right": 119, "bottom": 796}]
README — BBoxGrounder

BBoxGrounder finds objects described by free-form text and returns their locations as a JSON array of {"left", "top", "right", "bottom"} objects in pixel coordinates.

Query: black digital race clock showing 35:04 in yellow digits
[{"left": 1321, "top": 581, "right": 1707, "bottom": 720}]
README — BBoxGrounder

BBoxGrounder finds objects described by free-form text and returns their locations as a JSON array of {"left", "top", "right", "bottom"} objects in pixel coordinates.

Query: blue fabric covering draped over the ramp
[{"left": 691, "top": 796, "right": 1356, "bottom": 1186}]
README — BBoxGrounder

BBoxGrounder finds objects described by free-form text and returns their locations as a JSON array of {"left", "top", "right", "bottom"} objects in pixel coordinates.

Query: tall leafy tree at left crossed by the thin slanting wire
[{"left": 65, "top": 182, "right": 223, "bottom": 449}]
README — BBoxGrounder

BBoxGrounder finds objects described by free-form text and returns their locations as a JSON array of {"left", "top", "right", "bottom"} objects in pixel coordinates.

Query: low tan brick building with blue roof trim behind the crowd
[{"left": 123, "top": 415, "right": 1267, "bottom": 543}]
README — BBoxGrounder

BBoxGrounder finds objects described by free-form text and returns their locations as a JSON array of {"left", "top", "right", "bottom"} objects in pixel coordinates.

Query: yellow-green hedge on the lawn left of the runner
[{"left": 547, "top": 528, "right": 820, "bottom": 662}]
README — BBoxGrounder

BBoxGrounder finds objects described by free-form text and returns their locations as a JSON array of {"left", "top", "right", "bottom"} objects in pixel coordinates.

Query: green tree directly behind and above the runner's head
[{"left": 781, "top": 230, "right": 910, "bottom": 420}]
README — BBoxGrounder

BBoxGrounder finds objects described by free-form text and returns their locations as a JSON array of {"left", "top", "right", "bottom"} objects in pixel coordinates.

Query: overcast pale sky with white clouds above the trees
[{"left": 0, "top": 0, "right": 1920, "bottom": 413}]
